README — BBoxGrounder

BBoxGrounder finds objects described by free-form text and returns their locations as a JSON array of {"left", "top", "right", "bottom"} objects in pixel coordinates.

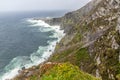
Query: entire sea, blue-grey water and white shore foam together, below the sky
[{"left": 0, "top": 11, "right": 66, "bottom": 80}]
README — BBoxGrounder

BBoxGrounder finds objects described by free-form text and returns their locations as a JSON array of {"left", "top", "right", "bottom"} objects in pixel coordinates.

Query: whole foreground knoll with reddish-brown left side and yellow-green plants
[{"left": 14, "top": 62, "right": 100, "bottom": 80}]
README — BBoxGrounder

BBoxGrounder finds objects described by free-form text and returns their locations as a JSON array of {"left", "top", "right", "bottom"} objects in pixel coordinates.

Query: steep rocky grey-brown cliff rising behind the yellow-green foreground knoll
[{"left": 13, "top": 0, "right": 120, "bottom": 80}]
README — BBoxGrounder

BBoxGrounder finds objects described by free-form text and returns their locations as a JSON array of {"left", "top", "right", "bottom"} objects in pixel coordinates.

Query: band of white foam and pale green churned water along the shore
[{"left": 0, "top": 19, "right": 65, "bottom": 80}]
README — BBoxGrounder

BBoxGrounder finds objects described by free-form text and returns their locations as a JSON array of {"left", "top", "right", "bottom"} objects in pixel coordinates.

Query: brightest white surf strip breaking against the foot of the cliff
[{"left": 1, "top": 18, "right": 65, "bottom": 80}]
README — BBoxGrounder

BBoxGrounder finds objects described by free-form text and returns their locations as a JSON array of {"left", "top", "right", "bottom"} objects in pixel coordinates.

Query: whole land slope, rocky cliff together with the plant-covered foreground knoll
[{"left": 13, "top": 0, "right": 120, "bottom": 80}]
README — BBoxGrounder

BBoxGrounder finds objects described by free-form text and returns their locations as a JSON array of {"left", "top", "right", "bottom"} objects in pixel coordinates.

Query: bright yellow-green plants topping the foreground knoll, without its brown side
[{"left": 41, "top": 63, "right": 100, "bottom": 80}]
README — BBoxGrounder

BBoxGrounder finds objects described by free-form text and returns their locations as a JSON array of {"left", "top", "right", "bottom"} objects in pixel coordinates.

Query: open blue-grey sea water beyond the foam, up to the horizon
[{"left": 0, "top": 11, "right": 65, "bottom": 79}]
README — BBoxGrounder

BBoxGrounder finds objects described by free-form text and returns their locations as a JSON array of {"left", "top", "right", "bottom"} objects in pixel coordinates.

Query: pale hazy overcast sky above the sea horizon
[{"left": 0, "top": 0, "right": 90, "bottom": 12}]
